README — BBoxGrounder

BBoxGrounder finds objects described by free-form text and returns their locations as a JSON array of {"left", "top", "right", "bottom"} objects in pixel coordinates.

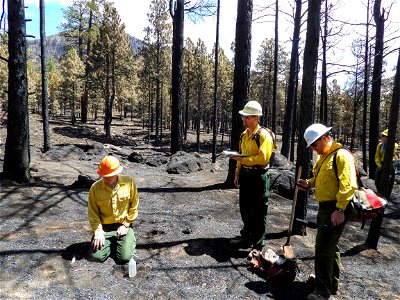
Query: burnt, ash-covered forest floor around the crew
[{"left": 0, "top": 118, "right": 400, "bottom": 299}]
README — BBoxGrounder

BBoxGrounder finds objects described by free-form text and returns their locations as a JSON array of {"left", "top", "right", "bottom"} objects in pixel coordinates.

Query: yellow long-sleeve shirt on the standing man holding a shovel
[{"left": 308, "top": 143, "right": 358, "bottom": 209}]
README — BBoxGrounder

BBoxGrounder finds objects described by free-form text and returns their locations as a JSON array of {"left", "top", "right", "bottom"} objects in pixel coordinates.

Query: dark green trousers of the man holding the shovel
[{"left": 315, "top": 201, "right": 346, "bottom": 298}]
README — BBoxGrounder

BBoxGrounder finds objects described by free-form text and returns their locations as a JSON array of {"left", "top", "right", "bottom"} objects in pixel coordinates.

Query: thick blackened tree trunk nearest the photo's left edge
[{"left": 3, "top": 0, "right": 31, "bottom": 182}]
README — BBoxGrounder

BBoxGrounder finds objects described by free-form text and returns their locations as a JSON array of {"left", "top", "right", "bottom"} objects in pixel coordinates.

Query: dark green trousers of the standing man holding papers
[{"left": 239, "top": 167, "right": 270, "bottom": 249}]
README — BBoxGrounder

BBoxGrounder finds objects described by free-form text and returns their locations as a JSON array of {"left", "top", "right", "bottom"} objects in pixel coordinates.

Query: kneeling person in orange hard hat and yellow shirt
[{"left": 88, "top": 155, "right": 139, "bottom": 264}]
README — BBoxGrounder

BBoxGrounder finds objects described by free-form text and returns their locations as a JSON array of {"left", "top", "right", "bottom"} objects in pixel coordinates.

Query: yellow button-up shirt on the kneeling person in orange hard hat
[{"left": 88, "top": 175, "right": 139, "bottom": 236}]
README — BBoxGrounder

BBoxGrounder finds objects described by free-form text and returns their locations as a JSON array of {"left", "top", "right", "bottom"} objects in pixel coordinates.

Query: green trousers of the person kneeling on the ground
[{"left": 89, "top": 228, "right": 136, "bottom": 264}]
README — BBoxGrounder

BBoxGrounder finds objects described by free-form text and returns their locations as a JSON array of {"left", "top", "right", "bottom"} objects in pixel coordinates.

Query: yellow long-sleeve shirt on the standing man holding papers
[{"left": 235, "top": 125, "right": 275, "bottom": 176}]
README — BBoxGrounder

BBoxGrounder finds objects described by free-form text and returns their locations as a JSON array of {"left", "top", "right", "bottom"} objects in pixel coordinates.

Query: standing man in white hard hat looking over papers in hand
[{"left": 231, "top": 101, "right": 275, "bottom": 249}]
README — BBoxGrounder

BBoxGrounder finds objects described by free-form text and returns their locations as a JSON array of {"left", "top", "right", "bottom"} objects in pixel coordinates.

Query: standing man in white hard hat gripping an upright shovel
[{"left": 297, "top": 124, "right": 358, "bottom": 300}]
